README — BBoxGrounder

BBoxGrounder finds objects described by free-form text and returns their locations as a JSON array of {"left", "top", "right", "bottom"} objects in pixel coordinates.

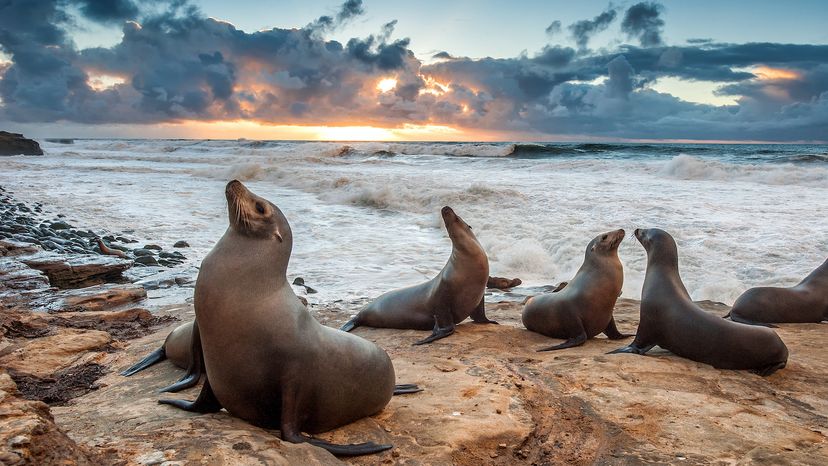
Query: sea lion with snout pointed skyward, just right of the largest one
[{"left": 340, "top": 206, "right": 497, "bottom": 345}]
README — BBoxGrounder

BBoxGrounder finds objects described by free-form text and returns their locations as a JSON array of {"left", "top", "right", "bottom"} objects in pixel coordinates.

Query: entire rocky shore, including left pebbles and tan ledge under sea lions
[{"left": 0, "top": 188, "right": 828, "bottom": 465}]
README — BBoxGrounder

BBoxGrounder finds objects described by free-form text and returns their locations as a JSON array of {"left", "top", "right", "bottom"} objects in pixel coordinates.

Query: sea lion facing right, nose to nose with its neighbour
[{"left": 521, "top": 230, "right": 632, "bottom": 351}]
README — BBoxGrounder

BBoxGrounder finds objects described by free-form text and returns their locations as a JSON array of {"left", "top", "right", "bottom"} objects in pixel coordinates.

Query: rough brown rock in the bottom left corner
[{"left": 0, "top": 369, "right": 104, "bottom": 465}]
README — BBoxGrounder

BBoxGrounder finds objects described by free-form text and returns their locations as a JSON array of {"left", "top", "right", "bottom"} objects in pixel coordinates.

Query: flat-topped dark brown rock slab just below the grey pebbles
[{"left": 19, "top": 253, "right": 133, "bottom": 288}]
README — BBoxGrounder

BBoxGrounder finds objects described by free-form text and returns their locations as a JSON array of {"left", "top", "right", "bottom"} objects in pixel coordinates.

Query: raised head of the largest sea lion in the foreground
[{"left": 224, "top": 180, "right": 293, "bottom": 247}]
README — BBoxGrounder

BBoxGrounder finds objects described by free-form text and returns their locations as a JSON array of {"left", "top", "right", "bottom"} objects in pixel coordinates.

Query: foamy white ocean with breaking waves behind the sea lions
[{"left": 0, "top": 139, "right": 828, "bottom": 304}]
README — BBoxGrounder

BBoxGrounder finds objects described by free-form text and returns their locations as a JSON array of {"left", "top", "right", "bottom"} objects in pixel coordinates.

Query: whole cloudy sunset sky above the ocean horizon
[{"left": 0, "top": 0, "right": 828, "bottom": 142}]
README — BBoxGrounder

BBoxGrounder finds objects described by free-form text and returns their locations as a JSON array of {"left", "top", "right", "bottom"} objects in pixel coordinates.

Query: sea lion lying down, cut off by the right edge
[{"left": 725, "top": 259, "right": 828, "bottom": 324}]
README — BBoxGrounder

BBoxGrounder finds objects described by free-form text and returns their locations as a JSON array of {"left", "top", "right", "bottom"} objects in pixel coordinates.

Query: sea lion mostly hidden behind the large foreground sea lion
[{"left": 121, "top": 321, "right": 204, "bottom": 392}]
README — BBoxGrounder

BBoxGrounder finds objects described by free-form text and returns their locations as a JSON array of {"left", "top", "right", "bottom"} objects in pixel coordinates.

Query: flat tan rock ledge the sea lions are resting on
[{"left": 52, "top": 299, "right": 828, "bottom": 465}]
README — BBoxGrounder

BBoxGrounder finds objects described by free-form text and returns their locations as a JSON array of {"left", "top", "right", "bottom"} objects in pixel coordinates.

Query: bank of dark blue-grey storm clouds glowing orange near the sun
[{"left": 0, "top": 0, "right": 828, "bottom": 140}]
